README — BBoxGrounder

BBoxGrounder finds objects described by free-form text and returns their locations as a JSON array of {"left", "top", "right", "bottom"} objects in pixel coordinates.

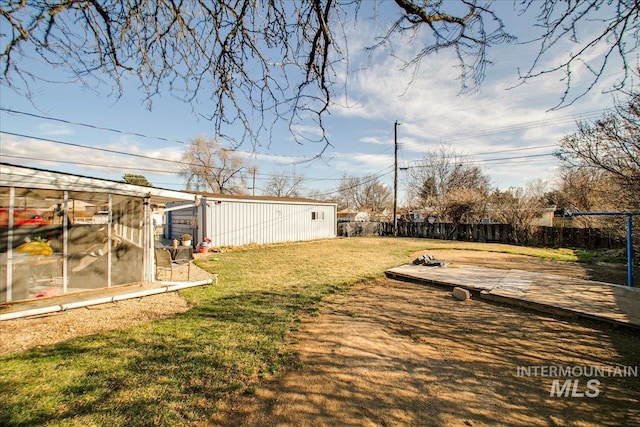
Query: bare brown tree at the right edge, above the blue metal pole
[{"left": 556, "top": 93, "right": 640, "bottom": 210}]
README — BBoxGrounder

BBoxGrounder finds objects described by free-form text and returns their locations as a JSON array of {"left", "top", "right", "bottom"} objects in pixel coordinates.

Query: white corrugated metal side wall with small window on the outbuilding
[{"left": 200, "top": 199, "right": 336, "bottom": 247}]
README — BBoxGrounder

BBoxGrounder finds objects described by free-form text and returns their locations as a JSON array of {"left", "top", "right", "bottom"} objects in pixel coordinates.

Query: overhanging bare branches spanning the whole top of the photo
[{"left": 0, "top": 0, "right": 640, "bottom": 149}]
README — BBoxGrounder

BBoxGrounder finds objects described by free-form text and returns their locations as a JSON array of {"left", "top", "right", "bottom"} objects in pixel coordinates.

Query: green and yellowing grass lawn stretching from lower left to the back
[{"left": 0, "top": 238, "right": 620, "bottom": 427}]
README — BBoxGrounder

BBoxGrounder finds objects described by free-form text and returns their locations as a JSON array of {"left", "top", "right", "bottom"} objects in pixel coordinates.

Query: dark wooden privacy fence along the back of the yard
[{"left": 338, "top": 221, "right": 625, "bottom": 249}]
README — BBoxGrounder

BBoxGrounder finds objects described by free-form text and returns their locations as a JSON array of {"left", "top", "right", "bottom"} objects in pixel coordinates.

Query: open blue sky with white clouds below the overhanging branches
[{"left": 0, "top": 2, "right": 622, "bottom": 202}]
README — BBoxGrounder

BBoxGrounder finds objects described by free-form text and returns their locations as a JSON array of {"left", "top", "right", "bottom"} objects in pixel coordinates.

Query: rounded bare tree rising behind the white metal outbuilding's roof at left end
[{"left": 180, "top": 136, "right": 253, "bottom": 194}]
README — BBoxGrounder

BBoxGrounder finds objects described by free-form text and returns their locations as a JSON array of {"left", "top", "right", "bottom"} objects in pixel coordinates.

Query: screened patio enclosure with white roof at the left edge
[{"left": 0, "top": 163, "right": 198, "bottom": 304}]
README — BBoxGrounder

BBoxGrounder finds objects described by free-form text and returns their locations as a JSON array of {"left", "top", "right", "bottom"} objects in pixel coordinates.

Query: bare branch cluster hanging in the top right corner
[{"left": 520, "top": 0, "right": 640, "bottom": 106}]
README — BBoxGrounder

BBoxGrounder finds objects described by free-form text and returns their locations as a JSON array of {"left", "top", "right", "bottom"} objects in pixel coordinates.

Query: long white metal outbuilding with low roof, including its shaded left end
[{"left": 165, "top": 193, "right": 337, "bottom": 247}]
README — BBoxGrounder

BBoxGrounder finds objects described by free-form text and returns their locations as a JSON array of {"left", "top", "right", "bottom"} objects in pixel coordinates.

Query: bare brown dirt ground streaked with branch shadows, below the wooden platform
[{"left": 212, "top": 280, "right": 640, "bottom": 426}]
